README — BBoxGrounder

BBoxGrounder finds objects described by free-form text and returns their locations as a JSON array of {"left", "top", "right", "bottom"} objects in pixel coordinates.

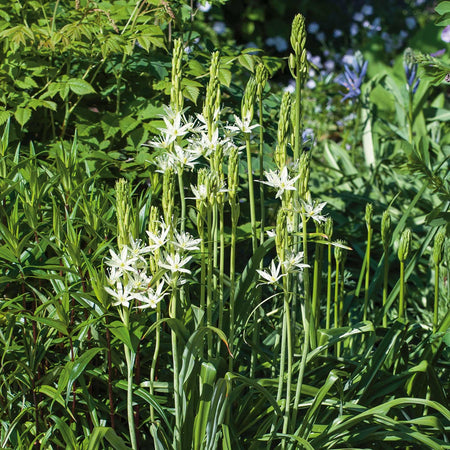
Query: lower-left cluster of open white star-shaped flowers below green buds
[{"left": 105, "top": 223, "right": 200, "bottom": 309}]
